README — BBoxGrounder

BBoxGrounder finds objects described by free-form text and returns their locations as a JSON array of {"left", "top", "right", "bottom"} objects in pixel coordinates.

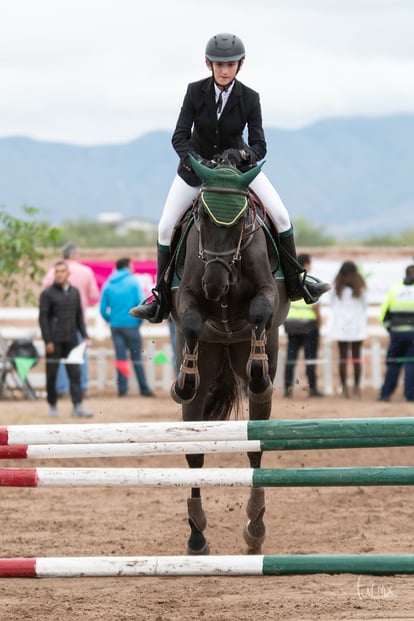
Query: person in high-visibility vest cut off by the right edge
[{"left": 378, "top": 265, "right": 414, "bottom": 401}]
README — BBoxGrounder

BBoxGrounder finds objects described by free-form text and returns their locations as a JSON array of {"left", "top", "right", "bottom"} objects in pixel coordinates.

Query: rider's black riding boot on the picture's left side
[{"left": 129, "top": 244, "right": 171, "bottom": 323}]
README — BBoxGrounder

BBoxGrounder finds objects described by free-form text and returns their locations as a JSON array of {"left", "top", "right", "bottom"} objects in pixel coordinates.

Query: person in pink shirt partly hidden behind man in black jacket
[{"left": 43, "top": 242, "right": 99, "bottom": 395}]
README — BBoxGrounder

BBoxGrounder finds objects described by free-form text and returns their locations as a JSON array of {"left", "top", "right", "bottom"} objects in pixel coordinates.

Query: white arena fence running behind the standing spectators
[{"left": 0, "top": 304, "right": 388, "bottom": 395}]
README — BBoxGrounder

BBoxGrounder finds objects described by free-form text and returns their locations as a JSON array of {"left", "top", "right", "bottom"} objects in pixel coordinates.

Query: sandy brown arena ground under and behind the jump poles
[{"left": 0, "top": 391, "right": 414, "bottom": 621}]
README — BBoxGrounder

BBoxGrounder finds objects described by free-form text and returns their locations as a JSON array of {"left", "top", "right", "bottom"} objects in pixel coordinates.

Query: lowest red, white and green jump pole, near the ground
[{"left": 0, "top": 554, "right": 414, "bottom": 578}]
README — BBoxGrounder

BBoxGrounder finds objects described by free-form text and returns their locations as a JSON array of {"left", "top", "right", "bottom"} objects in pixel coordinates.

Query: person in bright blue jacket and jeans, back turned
[{"left": 99, "top": 257, "right": 155, "bottom": 397}]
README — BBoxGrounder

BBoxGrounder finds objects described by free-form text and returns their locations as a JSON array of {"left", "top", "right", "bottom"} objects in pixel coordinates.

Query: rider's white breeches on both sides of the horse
[{"left": 158, "top": 172, "right": 291, "bottom": 246}]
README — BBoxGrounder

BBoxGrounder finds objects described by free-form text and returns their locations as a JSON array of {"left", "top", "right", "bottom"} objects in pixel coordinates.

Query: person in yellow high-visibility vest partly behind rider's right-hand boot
[{"left": 284, "top": 253, "right": 323, "bottom": 398}]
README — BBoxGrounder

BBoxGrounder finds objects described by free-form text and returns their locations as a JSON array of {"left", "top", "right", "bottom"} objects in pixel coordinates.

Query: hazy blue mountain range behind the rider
[{"left": 0, "top": 115, "right": 414, "bottom": 240}]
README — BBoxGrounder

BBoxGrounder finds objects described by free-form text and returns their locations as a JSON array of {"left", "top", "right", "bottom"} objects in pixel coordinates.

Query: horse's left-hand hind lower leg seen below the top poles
[{"left": 186, "top": 455, "right": 210, "bottom": 555}]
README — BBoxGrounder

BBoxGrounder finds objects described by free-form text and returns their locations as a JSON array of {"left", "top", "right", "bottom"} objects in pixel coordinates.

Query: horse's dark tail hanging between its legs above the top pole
[{"left": 203, "top": 347, "right": 241, "bottom": 420}]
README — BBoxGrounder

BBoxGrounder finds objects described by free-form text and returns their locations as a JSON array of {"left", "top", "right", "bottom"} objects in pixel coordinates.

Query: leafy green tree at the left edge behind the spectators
[{"left": 0, "top": 205, "right": 60, "bottom": 305}]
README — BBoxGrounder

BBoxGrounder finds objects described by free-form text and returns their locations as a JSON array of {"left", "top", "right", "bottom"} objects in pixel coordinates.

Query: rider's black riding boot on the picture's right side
[{"left": 279, "top": 231, "right": 331, "bottom": 304}]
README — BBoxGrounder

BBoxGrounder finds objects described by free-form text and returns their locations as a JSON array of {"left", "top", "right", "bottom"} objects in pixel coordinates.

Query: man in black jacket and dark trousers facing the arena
[{"left": 39, "top": 261, "right": 93, "bottom": 417}]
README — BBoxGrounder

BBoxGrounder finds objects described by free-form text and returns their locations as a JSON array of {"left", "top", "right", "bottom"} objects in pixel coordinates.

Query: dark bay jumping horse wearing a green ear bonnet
[{"left": 171, "top": 158, "right": 289, "bottom": 554}]
